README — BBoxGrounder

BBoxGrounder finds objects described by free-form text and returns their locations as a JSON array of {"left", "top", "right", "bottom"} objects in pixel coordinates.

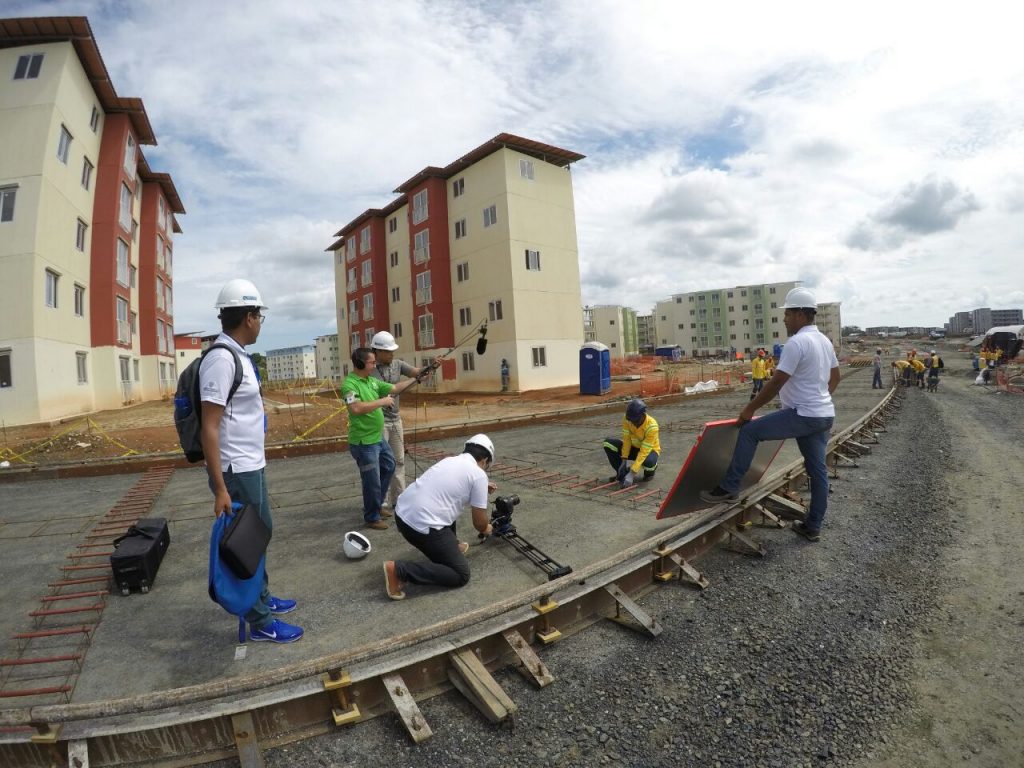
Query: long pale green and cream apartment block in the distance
[{"left": 654, "top": 282, "right": 798, "bottom": 357}]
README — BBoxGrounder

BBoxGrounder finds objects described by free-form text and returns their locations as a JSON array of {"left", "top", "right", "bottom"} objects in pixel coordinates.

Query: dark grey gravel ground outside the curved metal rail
[{"left": 211, "top": 362, "right": 1024, "bottom": 768}]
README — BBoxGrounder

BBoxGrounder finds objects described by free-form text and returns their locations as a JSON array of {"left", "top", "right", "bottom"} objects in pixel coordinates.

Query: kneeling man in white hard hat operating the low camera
[{"left": 384, "top": 434, "right": 498, "bottom": 600}]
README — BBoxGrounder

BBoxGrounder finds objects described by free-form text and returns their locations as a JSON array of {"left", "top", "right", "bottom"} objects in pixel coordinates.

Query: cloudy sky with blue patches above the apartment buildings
[{"left": 9, "top": 0, "right": 1024, "bottom": 348}]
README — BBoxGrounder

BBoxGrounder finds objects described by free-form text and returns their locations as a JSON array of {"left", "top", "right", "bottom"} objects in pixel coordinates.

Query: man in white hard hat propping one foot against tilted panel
[{"left": 700, "top": 288, "right": 840, "bottom": 542}]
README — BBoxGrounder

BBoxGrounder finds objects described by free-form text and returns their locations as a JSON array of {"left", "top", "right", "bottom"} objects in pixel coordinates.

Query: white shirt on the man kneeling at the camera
[{"left": 394, "top": 454, "right": 487, "bottom": 534}]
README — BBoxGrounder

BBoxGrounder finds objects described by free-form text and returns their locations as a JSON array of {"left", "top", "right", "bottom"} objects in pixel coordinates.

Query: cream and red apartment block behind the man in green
[{"left": 327, "top": 133, "right": 584, "bottom": 391}]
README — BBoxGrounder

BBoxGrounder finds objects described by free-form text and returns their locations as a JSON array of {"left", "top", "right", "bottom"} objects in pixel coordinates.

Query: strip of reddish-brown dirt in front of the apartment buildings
[{"left": 0, "top": 362, "right": 742, "bottom": 467}]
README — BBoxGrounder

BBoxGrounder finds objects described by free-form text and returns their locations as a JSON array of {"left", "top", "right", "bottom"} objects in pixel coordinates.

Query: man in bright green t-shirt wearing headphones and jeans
[{"left": 341, "top": 347, "right": 419, "bottom": 530}]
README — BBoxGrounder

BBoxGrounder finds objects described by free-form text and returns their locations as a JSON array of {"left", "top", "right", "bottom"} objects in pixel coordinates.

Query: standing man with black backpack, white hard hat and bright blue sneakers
[{"left": 199, "top": 280, "right": 302, "bottom": 643}]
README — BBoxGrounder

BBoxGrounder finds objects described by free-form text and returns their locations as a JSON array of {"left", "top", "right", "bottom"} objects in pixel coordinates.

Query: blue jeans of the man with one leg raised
[{"left": 719, "top": 408, "right": 835, "bottom": 530}]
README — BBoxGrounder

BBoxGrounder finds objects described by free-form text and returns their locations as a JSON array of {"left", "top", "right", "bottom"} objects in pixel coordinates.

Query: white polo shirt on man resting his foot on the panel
[{"left": 776, "top": 326, "right": 839, "bottom": 417}]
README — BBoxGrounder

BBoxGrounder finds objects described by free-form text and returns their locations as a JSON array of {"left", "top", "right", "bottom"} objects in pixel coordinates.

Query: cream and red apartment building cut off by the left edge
[{"left": 0, "top": 16, "right": 184, "bottom": 424}]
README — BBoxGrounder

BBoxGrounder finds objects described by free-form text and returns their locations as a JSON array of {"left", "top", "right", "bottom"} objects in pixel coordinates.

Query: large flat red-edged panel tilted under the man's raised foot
[{"left": 657, "top": 419, "right": 785, "bottom": 520}]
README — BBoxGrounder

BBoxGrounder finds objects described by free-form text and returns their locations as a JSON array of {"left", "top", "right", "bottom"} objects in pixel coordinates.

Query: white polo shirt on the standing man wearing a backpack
[{"left": 199, "top": 334, "right": 266, "bottom": 472}]
